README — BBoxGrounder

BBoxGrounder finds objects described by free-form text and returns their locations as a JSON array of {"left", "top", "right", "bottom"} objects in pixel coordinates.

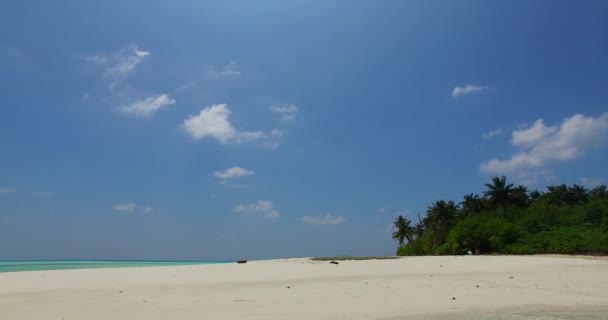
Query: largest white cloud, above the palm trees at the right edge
[{"left": 480, "top": 113, "right": 608, "bottom": 182}]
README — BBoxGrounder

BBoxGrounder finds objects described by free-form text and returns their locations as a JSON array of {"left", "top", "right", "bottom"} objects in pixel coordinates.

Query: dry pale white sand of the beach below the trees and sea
[{"left": 0, "top": 256, "right": 608, "bottom": 320}]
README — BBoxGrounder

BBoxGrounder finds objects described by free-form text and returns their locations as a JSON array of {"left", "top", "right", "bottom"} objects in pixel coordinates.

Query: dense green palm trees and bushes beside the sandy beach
[{"left": 393, "top": 177, "right": 608, "bottom": 256}]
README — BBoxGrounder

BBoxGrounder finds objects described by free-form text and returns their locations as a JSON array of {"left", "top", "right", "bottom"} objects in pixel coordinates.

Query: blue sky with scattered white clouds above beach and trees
[{"left": 0, "top": 0, "right": 608, "bottom": 260}]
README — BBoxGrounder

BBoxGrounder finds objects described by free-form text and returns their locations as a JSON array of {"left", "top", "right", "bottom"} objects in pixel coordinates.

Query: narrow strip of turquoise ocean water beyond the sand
[{"left": 0, "top": 260, "right": 228, "bottom": 272}]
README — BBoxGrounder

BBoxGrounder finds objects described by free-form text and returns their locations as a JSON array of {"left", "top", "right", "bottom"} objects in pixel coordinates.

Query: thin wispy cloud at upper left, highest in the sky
[{"left": 84, "top": 43, "right": 150, "bottom": 89}]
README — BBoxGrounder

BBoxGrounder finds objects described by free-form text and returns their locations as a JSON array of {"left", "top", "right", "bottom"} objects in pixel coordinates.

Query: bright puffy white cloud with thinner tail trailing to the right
[{"left": 182, "top": 104, "right": 283, "bottom": 147}]
